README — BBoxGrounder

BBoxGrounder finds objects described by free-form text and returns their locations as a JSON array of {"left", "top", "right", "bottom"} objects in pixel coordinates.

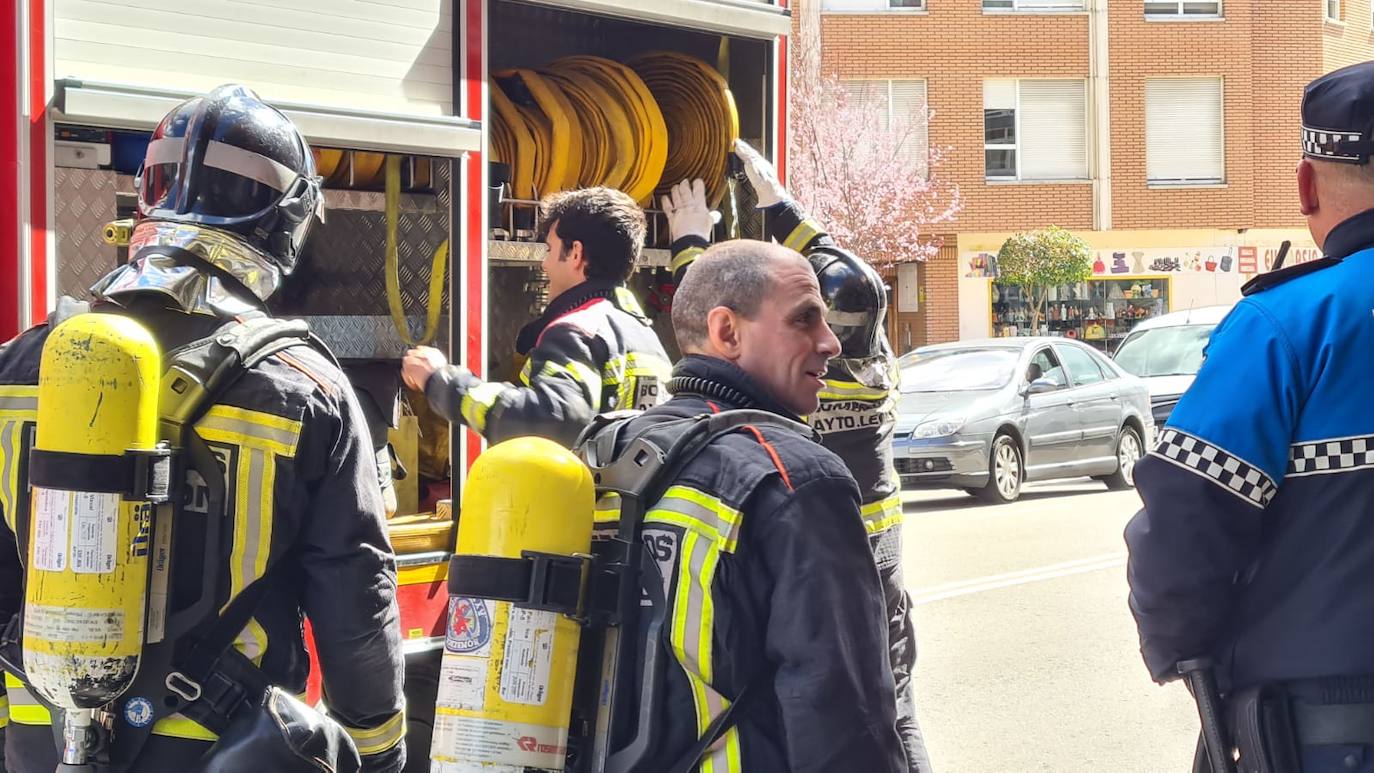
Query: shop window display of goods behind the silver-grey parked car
[{"left": 992, "top": 277, "right": 1169, "bottom": 353}]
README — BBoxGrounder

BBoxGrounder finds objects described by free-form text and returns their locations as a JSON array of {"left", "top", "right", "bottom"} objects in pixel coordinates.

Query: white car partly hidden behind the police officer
[{"left": 1112, "top": 303, "right": 1234, "bottom": 427}]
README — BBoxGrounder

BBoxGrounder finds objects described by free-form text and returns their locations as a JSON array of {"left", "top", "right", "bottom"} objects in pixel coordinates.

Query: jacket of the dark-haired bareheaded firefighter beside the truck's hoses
[{"left": 425, "top": 280, "right": 671, "bottom": 446}]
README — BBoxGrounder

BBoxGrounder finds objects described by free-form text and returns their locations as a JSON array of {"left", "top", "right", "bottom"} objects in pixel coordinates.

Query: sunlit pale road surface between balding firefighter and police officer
[{"left": 904, "top": 479, "right": 1198, "bottom": 773}]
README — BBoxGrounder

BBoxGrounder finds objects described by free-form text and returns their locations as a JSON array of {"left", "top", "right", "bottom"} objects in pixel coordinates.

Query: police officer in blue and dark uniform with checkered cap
[{"left": 1125, "top": 62, "right": 1374, "bottom": 773}]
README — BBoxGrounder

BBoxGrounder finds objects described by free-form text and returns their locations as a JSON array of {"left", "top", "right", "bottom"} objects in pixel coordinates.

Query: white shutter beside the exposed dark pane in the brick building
[{"left": 1021, "top": 81, "right": 1088, "bottom": 180}]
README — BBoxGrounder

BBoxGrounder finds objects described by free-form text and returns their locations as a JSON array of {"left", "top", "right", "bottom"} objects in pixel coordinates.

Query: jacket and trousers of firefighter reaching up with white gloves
[{"left": 673, "top": 202, "right": 930, "bottom": 773}]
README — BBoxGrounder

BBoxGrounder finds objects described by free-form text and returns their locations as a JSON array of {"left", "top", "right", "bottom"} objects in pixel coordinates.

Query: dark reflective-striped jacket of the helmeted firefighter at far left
[{"left": 0, "top": 295, "right": 406, "bottom": 773}]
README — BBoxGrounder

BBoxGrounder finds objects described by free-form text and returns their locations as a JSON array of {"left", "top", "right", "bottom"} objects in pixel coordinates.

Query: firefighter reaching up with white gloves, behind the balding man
[{"left": 662, "top": 141, "right": 932, "bottom": 773}]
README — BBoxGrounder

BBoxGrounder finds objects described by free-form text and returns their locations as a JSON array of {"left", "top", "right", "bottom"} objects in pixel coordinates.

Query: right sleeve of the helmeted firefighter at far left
[{"left": 297, "top": 367, "right": 403, "bottom": 773}]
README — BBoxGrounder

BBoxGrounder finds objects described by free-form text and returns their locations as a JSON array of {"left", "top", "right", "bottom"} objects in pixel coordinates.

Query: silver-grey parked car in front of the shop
[{"left": 893, "top": 338, "right": 1154, "bottom": 503}]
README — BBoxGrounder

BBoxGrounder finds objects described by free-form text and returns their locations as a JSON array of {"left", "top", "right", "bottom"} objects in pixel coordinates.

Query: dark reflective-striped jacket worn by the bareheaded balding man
[{"left": 607, "top": 356, "right": 907, "bottom": 773}]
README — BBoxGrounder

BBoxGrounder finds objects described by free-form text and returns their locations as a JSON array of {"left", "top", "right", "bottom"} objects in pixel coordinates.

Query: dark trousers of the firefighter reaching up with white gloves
[{"left": 877, "top": 526, "right": 933, "bottom": 773}]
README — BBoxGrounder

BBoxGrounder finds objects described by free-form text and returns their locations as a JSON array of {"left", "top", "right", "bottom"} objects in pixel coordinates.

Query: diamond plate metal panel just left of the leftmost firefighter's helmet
[{"left": 52, "top": 168, "right": 133, "bottom": 298}]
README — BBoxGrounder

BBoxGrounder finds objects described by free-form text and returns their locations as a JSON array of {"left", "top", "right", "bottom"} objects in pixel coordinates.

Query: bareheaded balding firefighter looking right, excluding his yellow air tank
[{"left": 596, "top": 240, "right": 905, "bottom": 773}]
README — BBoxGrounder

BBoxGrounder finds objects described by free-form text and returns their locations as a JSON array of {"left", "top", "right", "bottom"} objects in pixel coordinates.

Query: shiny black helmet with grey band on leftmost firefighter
[{"left": 136, "top": 85, "right": 323, "bottom": 273}]
